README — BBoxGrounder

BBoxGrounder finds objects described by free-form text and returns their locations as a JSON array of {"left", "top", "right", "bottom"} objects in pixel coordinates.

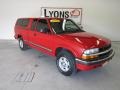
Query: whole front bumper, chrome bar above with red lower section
[{"left": 75, "top": 51, "right": 115, "bottom": 70}]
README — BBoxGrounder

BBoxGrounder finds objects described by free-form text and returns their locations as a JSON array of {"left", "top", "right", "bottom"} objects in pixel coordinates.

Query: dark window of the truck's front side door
[{"left": 36, "top": 19, "right": 49, "bottom": 32}]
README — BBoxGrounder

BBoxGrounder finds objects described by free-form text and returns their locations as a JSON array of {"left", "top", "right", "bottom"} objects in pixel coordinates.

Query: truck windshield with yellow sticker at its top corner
[{"left": 50, "top": 19, "right": 84, "bottom": 34}]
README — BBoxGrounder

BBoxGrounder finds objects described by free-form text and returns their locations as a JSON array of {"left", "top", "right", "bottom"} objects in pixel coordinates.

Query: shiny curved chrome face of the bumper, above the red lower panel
[{"left": 75, "top": 51, "right": 115, "bottom": 65}]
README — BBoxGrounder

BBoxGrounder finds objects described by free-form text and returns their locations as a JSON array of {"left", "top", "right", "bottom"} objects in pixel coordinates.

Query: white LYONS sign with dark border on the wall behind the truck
[{"left": 41, "top": 7, "right": 82, "bottom": 24}]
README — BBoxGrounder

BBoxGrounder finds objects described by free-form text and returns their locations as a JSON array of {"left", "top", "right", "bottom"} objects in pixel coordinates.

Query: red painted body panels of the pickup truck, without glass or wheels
[{"left": 15, "top": 18, "right": 111, "bottom": 70}]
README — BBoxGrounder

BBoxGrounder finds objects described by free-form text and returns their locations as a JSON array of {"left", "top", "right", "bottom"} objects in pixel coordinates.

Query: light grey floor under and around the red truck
[{"left": 0, "top": 40, "right": 120, "bottom": 90}]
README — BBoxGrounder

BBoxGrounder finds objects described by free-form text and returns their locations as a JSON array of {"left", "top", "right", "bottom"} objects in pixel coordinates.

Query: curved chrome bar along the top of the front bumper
[{"left": 75, "top": 51, "right": 115, "bottom": 65}]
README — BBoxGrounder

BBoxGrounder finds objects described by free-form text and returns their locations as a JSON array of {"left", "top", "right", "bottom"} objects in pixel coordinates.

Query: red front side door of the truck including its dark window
[{"left": 35, "top": 19, "right": 53, "bottom": 53}]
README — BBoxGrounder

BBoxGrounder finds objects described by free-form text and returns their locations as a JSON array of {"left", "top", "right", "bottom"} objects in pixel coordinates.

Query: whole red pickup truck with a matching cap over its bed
[{"left": 14, "top": 18, "right": 114, "bottom": 76}]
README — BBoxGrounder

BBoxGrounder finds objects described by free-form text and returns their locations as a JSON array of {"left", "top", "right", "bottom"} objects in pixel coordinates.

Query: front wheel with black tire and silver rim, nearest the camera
[{"left": 56, "top": 50, "right": 77, "bottom": 76}]
